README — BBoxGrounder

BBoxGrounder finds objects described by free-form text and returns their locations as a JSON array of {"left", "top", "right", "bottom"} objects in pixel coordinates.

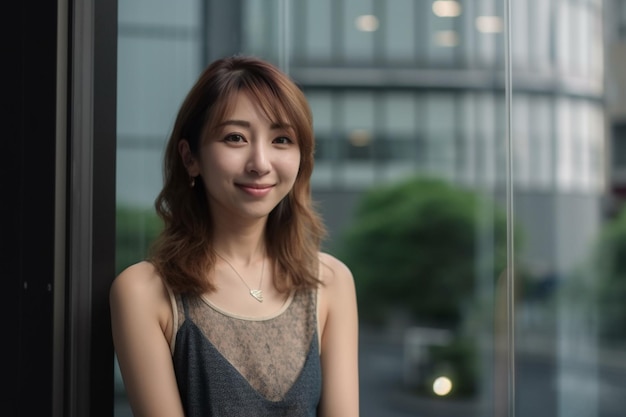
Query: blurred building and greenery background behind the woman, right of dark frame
[{"left": 115, "top": 0, "right": 626, "bottom": 417}]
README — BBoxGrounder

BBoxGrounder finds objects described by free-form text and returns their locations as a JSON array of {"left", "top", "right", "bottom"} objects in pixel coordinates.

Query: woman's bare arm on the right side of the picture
[{"left": 319, "top": 250, "right": 359, "bottom": 417}]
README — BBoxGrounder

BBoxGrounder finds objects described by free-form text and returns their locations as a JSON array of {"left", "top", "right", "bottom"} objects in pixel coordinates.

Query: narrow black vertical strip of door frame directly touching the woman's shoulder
[{"left": 89, "top": 0, "right": 117, "bottom": 417}]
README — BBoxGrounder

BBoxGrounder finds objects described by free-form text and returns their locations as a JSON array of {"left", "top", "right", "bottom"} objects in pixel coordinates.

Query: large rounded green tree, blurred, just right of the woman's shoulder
[{"left": 338, "top": 177, "right": 506, "bottom": 330}]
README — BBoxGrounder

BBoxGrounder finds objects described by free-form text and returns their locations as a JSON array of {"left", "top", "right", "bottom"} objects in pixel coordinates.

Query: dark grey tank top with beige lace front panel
[{"left": 173, "top": 291, "right": 322, "bottom": 417}]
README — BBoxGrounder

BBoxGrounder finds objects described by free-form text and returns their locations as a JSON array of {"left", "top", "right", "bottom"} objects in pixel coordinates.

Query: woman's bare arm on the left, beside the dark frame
[{"left": 110, "top": 262, "right": 184, "bottom": 417}]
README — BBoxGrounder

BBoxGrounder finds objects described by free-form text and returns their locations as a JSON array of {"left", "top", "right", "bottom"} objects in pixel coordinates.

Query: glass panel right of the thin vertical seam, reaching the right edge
[{"left": 512, "top": 0, "right": 626, "bottom": 417}]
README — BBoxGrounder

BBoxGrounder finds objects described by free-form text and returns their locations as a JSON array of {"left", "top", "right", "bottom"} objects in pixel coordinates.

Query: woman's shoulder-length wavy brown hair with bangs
[{"left": 149, "top": 56, "right": 326, "bottom": 294}]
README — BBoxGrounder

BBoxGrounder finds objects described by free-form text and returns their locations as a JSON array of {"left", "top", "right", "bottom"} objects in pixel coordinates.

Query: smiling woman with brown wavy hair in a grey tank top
[{"left": 110, "top": 56, "right": 359, "bottom": 417}]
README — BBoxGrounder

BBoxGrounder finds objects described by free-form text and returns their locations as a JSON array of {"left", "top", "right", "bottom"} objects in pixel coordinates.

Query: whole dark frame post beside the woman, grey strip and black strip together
[{"left": 64, "top": 0, "right": 117, "bottom": 417}]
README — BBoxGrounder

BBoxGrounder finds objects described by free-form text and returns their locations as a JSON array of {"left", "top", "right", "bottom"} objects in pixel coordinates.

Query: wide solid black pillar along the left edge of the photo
[{"left": 0, "top": 0, "right": 57, "bottom": 416}]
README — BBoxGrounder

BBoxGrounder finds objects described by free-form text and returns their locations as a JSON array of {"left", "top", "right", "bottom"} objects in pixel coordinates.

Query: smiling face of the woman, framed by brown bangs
[{"left": 181, "top": 92, "right": 300, "bottom": 220}]
